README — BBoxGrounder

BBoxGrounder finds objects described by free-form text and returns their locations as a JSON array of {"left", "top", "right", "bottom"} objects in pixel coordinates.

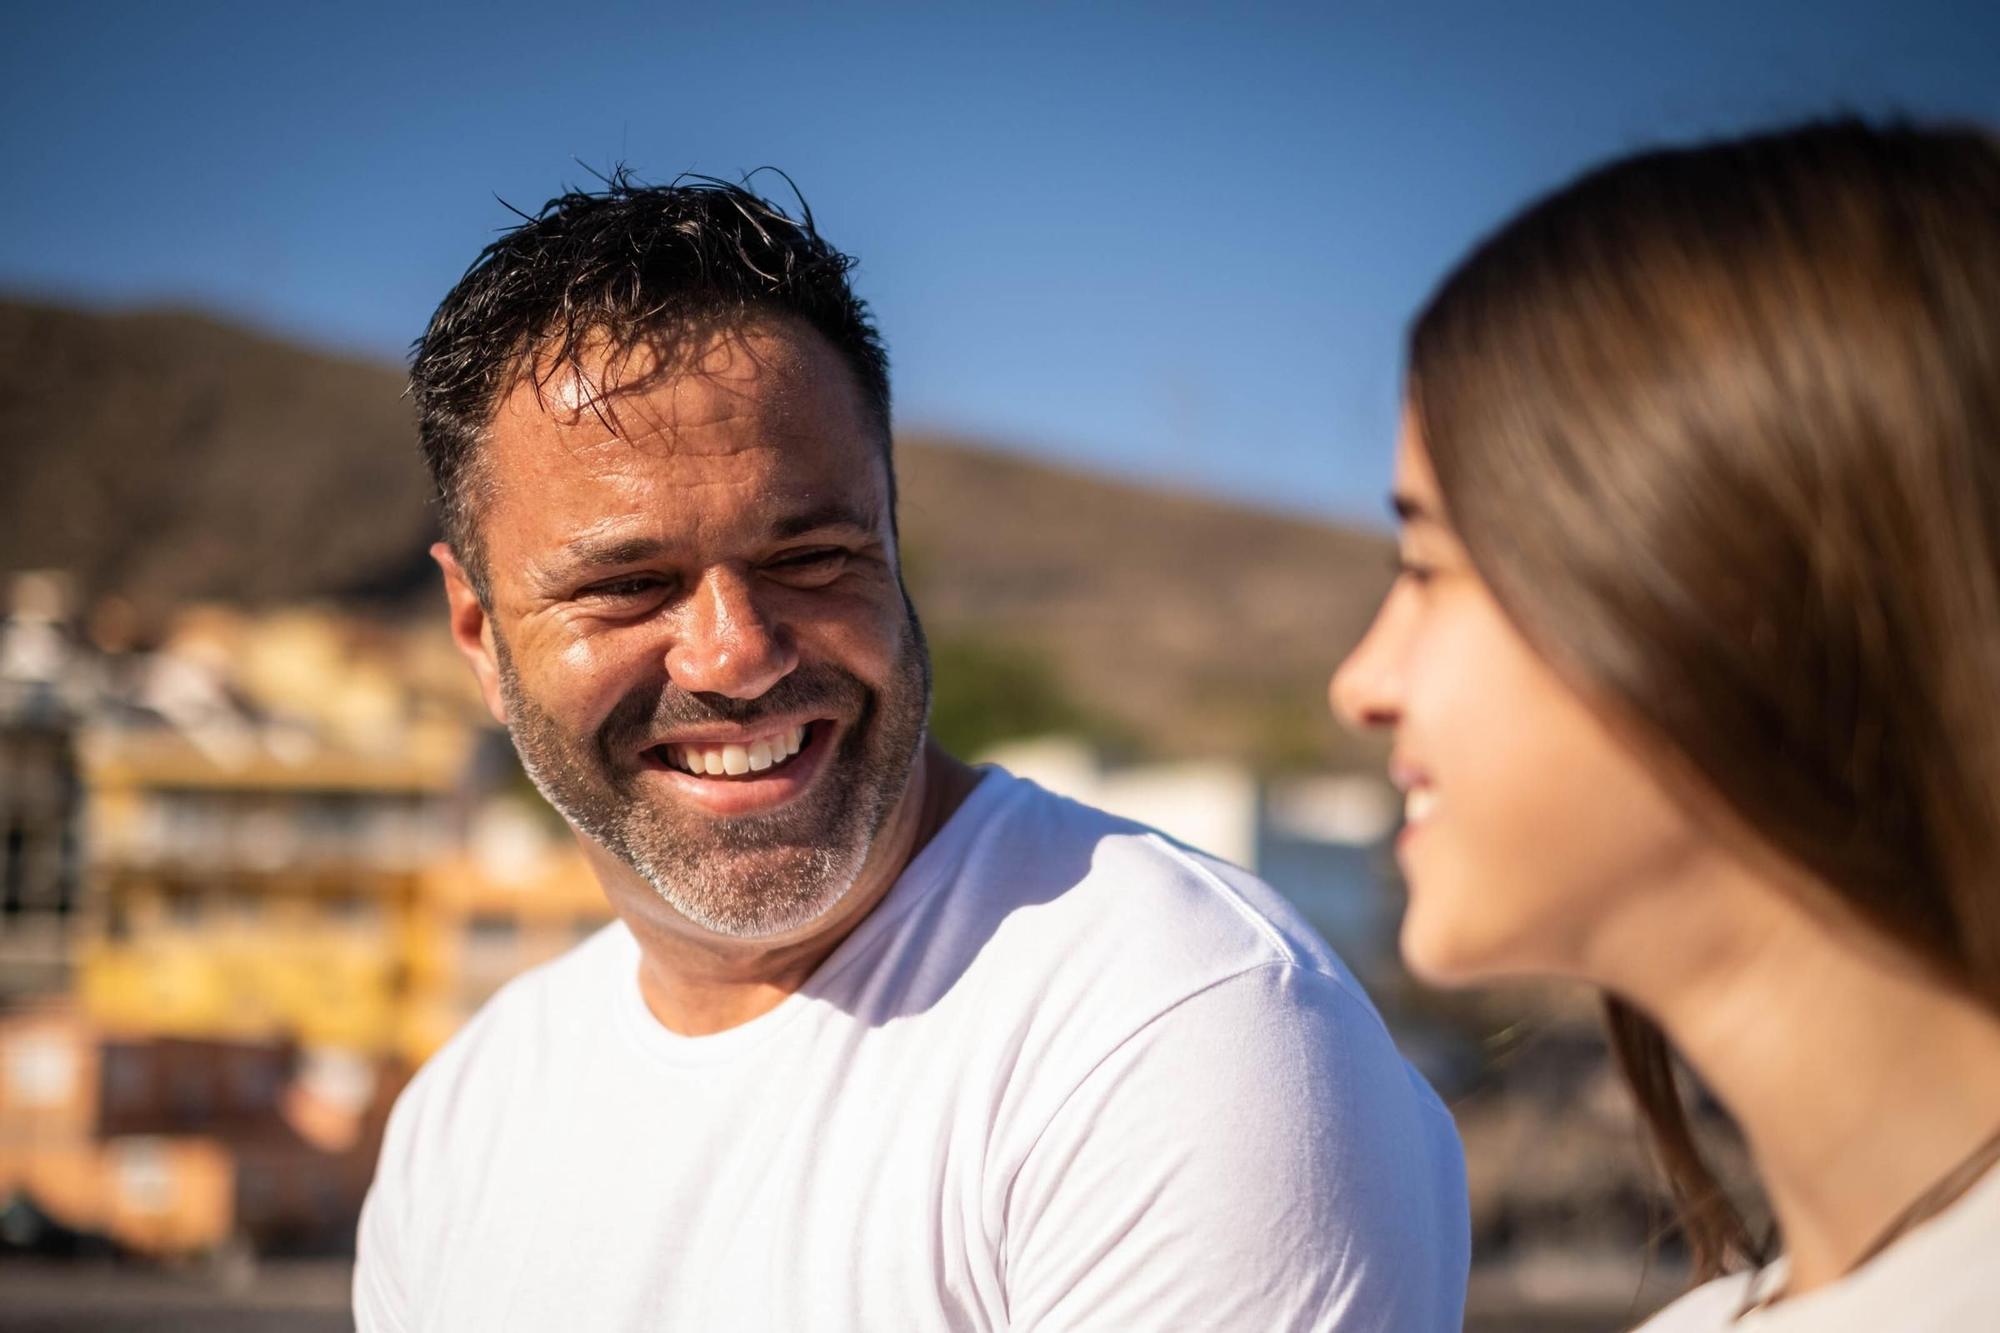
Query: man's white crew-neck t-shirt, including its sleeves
[{"left": 354, "top": 771, "right": 1470, "bottom": 1333}]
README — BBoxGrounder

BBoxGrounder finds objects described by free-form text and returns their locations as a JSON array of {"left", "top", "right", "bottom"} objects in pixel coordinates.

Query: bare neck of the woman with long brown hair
[{"left": 1642, "top": 888, "right": 2000, "bottom": 1293}]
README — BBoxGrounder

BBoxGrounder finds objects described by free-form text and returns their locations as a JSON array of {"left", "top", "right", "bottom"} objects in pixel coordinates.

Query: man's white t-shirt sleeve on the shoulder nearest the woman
[{"left": 1004, "top": 963, "right": 1470, "bottom": 1333}]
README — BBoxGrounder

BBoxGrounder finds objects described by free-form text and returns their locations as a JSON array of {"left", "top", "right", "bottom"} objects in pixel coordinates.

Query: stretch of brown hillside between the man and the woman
[{"left": 898, "top": 438, "right": 1390, "bottom": 763}]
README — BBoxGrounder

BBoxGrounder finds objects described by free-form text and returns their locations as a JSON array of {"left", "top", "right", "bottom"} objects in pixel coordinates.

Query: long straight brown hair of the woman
[{"left": 1410, "top": 120, "right": 2000, "bottom": 1277}]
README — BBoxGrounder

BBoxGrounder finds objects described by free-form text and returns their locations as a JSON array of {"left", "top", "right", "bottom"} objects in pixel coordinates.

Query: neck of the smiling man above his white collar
[{"left": 600, "top": 741, "right": 978, "bottom": 1037}]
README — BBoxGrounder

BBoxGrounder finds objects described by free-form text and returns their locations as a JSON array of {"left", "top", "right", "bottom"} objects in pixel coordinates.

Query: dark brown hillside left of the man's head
[{"left": 0, "top": 302, "right": 430, "bottom": 604}]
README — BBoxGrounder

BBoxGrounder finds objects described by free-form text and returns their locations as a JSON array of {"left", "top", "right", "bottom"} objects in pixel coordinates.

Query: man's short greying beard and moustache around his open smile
[{"left": 494, "top": 602, "right": 930, "bottom": 939}]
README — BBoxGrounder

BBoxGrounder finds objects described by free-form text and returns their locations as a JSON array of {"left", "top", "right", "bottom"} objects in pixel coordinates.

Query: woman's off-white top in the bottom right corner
[{"left": 1642, "top": 1169, "right": 2000, "bottom": 1333}]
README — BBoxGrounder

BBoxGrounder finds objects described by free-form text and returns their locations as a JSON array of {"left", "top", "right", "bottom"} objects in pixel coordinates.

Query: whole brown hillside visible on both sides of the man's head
[{"left": 0, "top": 302, "right": 1388, "bottom": 761}]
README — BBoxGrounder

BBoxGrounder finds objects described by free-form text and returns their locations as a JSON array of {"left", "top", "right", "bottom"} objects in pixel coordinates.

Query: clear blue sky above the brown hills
[{"left": 0, "top": 0, "right": 2000, "bottom": 518}]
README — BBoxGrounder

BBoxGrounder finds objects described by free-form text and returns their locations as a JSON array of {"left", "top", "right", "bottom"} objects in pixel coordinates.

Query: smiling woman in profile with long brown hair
[{"left": 1332, "top": 122, "right": 2000, "bottom": 1333}]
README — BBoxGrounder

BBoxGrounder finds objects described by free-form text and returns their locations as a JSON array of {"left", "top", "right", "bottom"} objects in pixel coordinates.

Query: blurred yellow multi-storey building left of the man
[{"left": 78, "top": 610, "right": 610, "bottom": 1067}]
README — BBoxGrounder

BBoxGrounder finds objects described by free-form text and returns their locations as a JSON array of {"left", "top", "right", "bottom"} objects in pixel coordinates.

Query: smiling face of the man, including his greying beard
[{"left": 464, "top": 320, "right": 930, "bottom": 939}]
